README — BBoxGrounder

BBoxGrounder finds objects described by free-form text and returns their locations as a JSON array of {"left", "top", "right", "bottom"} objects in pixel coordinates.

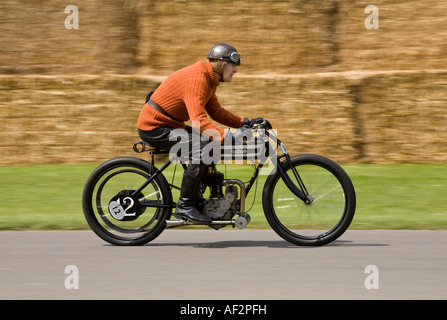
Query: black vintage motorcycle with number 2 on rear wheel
[{"left": 82, "top": 119, "right": 356, "bottom": 246}]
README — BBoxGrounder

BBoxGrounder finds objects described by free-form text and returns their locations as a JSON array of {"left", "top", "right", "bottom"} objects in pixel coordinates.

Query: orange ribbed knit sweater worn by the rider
[{"left": 137, "top": 61, "right": 243, "bottom": 141}]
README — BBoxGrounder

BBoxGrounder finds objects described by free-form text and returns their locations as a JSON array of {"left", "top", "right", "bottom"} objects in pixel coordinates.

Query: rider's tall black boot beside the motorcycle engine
[{"left": 174, "top": 164, "right": 211, "bottom": 223}]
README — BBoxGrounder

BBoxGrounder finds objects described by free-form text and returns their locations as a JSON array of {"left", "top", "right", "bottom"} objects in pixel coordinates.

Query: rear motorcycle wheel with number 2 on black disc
[{"left": 82, "top": 157, "right": 172, "bottom": 245}]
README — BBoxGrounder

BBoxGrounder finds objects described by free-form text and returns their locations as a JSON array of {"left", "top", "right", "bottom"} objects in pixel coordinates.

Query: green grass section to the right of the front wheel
[{"left": 344, "top": 164, "right": 447, "bottom": 229}]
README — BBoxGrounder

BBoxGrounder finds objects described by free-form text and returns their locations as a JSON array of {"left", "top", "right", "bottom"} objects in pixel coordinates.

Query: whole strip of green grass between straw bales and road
[{"left": 0, "top": 164, "right": 447, "bottom": 230}]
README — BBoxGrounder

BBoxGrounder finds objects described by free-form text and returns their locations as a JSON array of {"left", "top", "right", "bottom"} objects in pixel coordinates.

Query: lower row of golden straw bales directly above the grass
[{"left": 0, "top": 71, "right": 447, "bottom": 165}]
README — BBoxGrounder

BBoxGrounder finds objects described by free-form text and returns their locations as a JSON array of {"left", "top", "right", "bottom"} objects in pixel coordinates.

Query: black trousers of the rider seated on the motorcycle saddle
[{"left": 138, "top": 126, "right": 209, "bottom": 199}]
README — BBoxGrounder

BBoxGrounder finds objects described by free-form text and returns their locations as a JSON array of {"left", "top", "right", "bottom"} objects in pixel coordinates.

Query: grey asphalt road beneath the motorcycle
[{"left": 0, "top": 228, "right": 447, "bottom": 300}]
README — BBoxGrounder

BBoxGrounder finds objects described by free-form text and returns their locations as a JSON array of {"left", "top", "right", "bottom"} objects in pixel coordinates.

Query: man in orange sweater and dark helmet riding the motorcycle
[{"left": 138, "top": 43, "right": 249, "bottom": 223}]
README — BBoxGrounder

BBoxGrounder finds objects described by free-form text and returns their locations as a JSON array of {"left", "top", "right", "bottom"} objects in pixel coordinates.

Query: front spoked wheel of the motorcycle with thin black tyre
[{"left": 262, "top": 154, "right": 356, "bottom": 246}]
